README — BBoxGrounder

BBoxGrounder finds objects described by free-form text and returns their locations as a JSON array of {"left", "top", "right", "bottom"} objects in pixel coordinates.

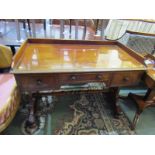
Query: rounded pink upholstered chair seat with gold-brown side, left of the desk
[{"left": 0, "top": 74, "right": 20, "bottom": 132}]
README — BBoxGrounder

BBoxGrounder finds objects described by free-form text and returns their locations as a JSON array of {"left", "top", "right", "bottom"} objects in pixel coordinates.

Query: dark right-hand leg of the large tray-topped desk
[{"left": 109, "top": 87, "right": 121, "bottom": 118}]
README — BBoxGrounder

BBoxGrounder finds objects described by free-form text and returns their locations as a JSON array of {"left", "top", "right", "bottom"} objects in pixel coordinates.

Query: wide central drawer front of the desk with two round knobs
[{"left": 59, "top": 73, "right": 110, "bottom": 84}]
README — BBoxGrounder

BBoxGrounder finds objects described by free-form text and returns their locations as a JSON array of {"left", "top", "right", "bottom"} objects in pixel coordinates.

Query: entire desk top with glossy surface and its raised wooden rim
[{"left": 12, "top": 39, "right": 145, "bottom": 73}]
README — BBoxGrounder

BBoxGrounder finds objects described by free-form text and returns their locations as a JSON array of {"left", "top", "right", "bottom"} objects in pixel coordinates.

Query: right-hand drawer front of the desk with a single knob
[{"left": 110, "top": 72, "right": 142, "bottom": 87}]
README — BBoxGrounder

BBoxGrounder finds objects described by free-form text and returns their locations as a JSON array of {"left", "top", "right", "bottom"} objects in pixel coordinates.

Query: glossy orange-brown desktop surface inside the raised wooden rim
[{"left": 14, "top": 43, "right": 144, "bottom": 72}]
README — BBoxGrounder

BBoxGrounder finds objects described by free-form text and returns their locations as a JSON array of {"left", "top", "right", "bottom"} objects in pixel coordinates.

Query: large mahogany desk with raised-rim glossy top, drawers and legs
[{"left": 12, "top": 39, "right": 146, "bottom": 132}]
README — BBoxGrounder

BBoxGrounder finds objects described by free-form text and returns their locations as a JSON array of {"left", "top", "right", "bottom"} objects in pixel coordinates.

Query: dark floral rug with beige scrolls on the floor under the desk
[{"left": 53, "top": 93, "right": 135, "bottom": 135}]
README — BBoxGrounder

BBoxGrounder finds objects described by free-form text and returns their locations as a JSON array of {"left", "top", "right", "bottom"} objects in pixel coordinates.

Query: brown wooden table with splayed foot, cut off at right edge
[{"left": 129, "top": 54, "right": 155, "bottom": 130}]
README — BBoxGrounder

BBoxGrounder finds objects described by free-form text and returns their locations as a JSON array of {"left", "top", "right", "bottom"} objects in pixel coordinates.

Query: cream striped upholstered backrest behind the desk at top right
[{"left": 105, "top": 19, "right": 155, "bottom": 40}]
